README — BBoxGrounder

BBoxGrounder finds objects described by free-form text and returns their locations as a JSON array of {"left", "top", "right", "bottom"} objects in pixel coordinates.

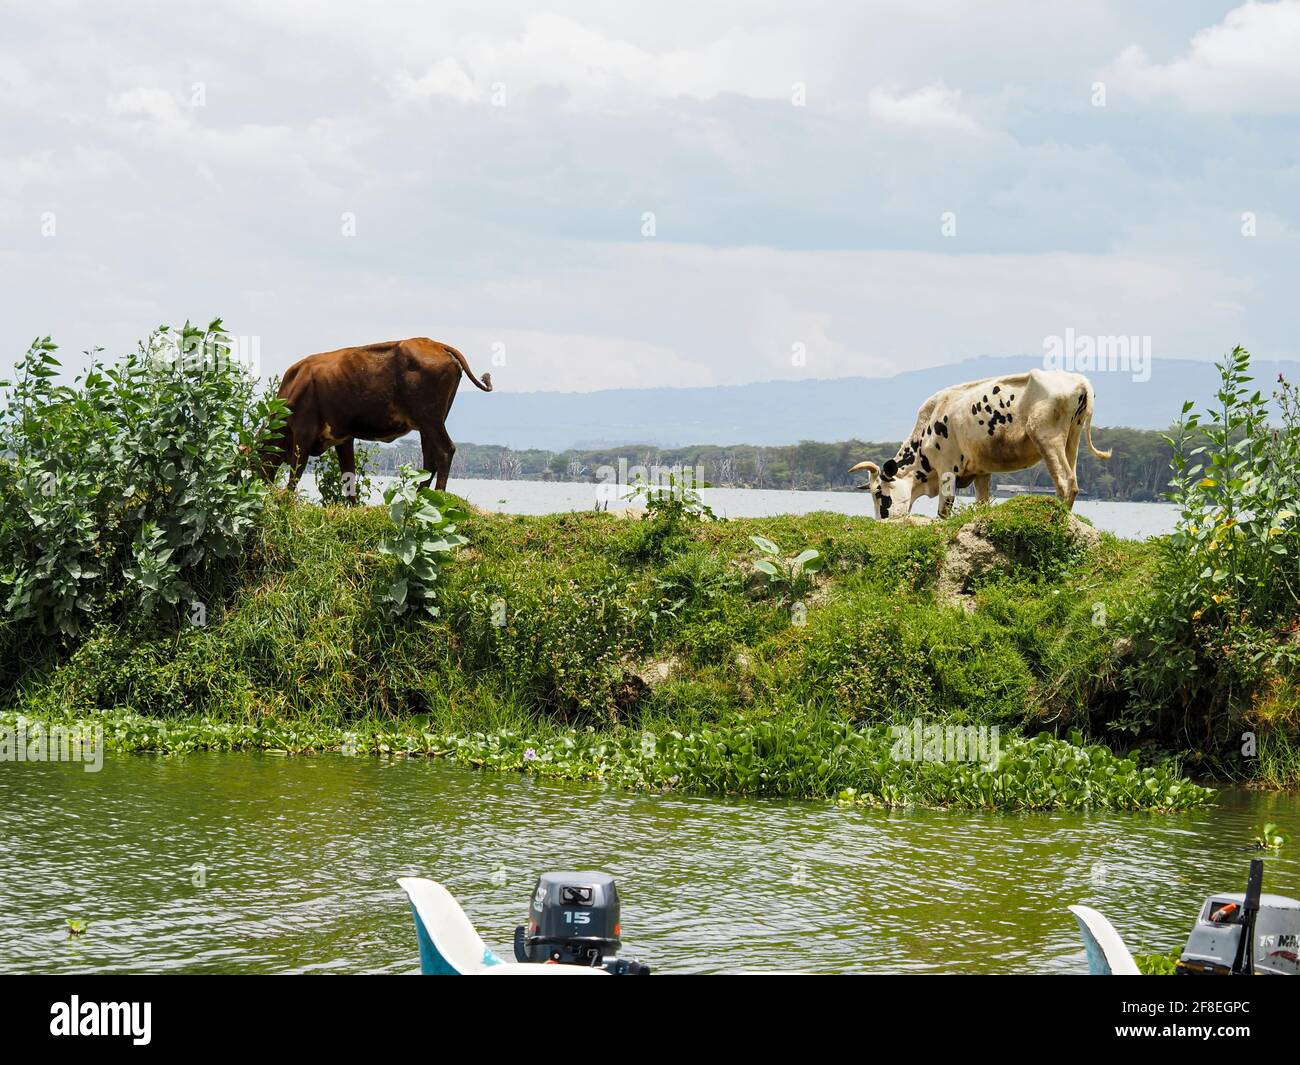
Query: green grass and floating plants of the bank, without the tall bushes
[{"left": 0, "top": 499, "right": 1295, "bottom": 806}]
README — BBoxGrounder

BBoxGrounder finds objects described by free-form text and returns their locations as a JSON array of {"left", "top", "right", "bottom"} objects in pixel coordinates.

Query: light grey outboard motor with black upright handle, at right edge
[{"left": 1177, "top": 858, "right": 1300, "bottom": 977}]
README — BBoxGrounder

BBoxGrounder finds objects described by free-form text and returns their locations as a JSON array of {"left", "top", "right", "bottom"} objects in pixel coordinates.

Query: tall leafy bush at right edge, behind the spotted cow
[{"left": 1131, "top": 347, "right": 1300, "bottom": 749}]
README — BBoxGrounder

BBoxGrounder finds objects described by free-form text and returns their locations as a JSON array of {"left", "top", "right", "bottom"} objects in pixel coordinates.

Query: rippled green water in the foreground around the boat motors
[{"left": 0, "top": 754, "right": 1300, "bottom": 973}]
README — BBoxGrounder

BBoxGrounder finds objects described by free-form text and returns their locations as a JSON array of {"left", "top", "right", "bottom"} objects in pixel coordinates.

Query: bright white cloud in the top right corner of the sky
[{"left": 1112, "top": 0, "right": 1300, "bottom": 114}]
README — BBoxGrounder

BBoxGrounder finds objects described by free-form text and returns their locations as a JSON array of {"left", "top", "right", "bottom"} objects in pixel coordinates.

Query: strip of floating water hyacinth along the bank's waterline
[{"left": 0, "top": 711, "right": 1213, "bottom": 810}]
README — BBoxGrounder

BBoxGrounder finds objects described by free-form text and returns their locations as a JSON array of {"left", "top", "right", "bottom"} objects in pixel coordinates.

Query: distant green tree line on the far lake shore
[{"left": 361, "top": 427, "right": 1173, "bottom": 502}]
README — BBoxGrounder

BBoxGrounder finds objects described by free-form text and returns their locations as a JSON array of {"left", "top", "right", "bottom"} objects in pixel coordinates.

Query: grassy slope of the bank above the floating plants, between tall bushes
[{"left": 0, "top": 499, "right": 1151, "bottom": 730}]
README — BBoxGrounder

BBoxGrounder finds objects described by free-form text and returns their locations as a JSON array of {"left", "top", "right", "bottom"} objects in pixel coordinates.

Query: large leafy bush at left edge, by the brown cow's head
[{"left": 0, "top": 319, "right": 285, "bottom": 636}]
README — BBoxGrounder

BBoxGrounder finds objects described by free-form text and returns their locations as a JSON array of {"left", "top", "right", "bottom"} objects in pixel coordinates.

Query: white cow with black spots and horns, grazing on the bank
[{"left": 849, "top": 369, "right": 1110, "bottom": 518}]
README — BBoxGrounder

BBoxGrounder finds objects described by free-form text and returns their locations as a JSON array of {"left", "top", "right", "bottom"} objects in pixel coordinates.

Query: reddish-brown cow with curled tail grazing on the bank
[{"left": 264, "top": 337, "right": 491, "bottom": 489}]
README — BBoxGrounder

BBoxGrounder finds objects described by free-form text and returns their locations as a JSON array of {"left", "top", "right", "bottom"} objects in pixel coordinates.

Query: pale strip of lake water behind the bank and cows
[{"left": 303, "top": 477, "right": 1178, "bottom": 540}]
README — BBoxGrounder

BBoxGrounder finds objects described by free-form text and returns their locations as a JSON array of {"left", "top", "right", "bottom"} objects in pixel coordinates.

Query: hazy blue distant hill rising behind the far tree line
[{"left": 449, "top": 356, "right": 1300, "bottom": 451}]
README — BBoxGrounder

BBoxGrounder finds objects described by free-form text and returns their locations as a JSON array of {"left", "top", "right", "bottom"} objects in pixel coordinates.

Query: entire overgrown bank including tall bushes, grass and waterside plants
[{"left": 0, "top": 332, "right": 1300, "bottom": 806}]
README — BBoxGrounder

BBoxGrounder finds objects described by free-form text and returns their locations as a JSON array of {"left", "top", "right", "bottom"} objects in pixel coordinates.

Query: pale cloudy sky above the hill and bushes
[{"left": 0, "top": 0, "right": 1300, "bottom": 390}]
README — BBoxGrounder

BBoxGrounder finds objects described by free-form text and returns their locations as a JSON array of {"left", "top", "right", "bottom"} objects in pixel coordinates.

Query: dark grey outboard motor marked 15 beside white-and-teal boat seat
[{"left": 515, "top": 873, "right": 650, "bottom": 975}]
